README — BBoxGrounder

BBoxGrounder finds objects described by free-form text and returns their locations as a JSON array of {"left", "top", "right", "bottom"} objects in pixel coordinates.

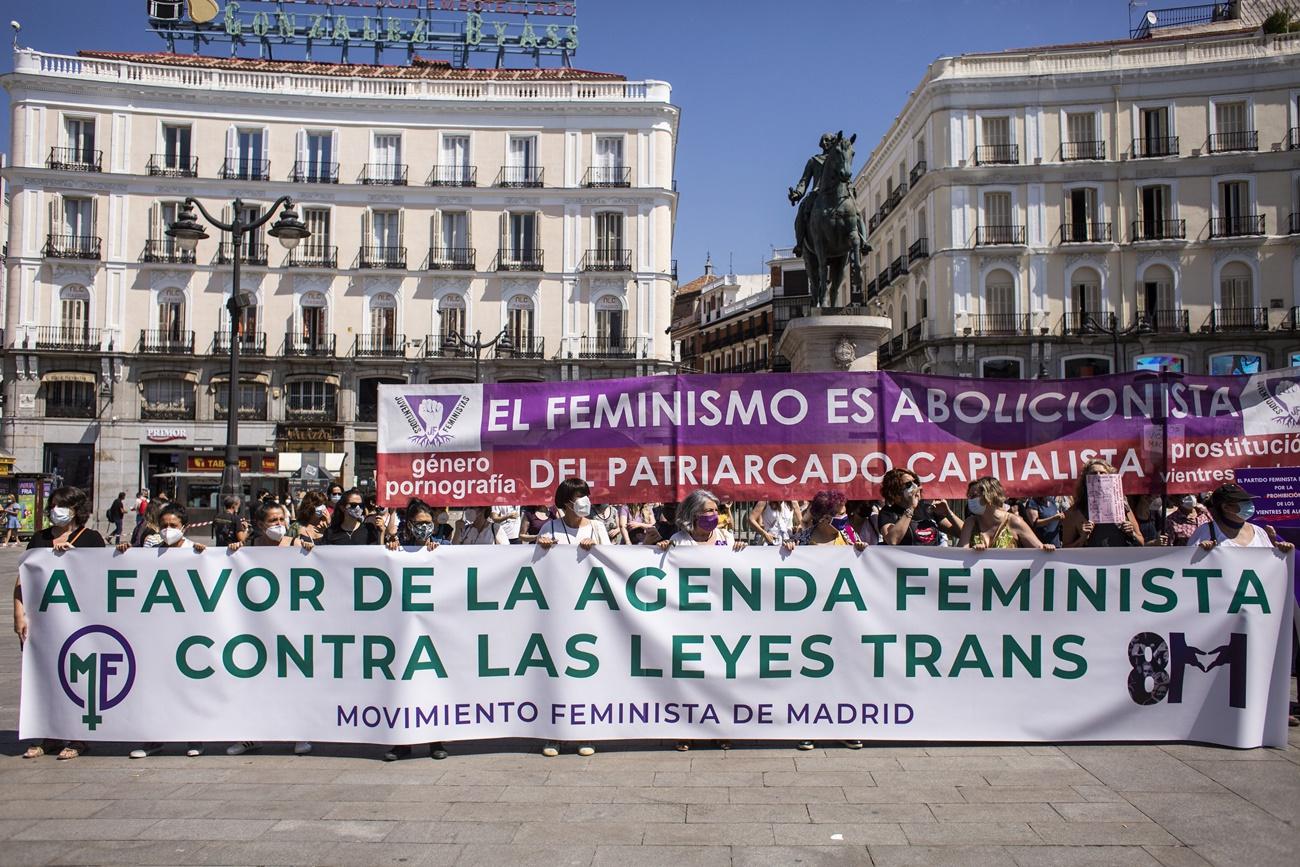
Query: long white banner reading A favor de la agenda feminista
[{"left": 21, "top": 546, "right": 1295, "bottom": 747}]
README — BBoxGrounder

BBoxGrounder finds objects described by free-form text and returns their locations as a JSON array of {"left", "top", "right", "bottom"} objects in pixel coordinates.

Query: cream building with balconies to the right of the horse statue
[{"left": 855, "top": 0, "right": 1300, "bottom": 377}]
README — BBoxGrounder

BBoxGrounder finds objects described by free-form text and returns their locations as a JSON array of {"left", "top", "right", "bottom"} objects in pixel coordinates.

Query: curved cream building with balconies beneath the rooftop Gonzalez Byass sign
[{"left": 0, "top": 48, "right": 679, "bottom": 513}]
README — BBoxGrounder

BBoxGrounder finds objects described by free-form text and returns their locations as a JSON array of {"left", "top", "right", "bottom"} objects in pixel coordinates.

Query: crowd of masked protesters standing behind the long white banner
[{"left": 14, "top": 460, "right": 1297, "bottom": 760}]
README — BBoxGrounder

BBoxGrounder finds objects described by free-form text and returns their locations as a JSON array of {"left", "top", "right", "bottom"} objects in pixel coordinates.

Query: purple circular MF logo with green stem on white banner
[{"left": 59, "top": 625, "right": 135, "bottom": 732}]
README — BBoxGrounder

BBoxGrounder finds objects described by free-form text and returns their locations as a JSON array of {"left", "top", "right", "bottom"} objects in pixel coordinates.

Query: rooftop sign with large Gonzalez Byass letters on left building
[{"left": 148, "top": 0, "right": 579, "bottom": 66}]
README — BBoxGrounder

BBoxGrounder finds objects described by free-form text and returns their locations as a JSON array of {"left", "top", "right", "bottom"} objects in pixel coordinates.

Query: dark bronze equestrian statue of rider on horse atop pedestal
[{"left": 789, "top": 131, "right": 871, "bottom": 308}]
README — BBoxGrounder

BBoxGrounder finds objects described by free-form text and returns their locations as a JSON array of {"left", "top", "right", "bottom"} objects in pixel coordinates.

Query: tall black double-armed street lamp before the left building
[{"left": 166, "top": 196, "right": 312, "bottom": 497}]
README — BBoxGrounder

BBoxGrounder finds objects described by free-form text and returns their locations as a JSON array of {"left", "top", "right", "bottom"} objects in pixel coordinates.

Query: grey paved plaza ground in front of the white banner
[{"left": 0, "top": 549, "right": 1300, "bottom": 867}]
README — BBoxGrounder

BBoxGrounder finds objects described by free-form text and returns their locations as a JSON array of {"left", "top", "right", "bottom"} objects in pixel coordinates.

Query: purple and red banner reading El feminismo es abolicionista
[{"left": 378, "top": 370, "right": 1300, "bottom": 506}]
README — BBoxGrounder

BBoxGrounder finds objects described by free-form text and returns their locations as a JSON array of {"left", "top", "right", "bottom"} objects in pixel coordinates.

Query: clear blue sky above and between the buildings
[{"left": 0, "top": 0, "right": 1128, "bottom": 281}]
